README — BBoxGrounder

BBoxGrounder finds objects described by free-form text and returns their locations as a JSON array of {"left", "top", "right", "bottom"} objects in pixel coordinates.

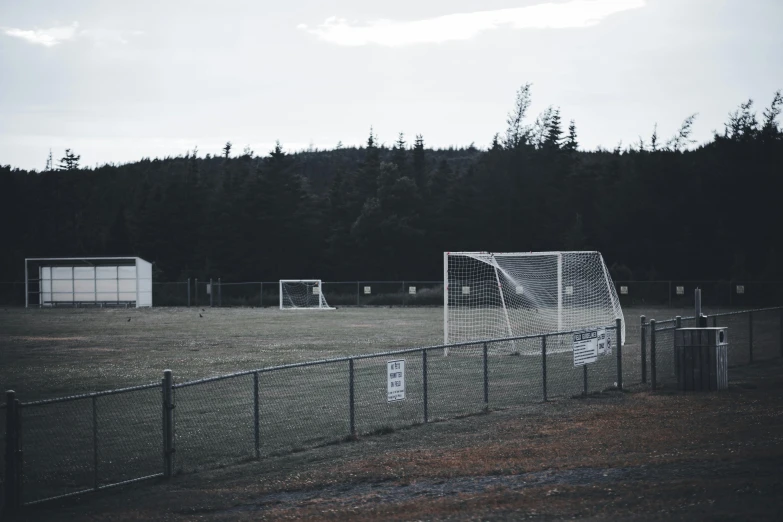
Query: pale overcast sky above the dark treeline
[{"left": 0, "top": 0, "right": 783, "bottom": 170}]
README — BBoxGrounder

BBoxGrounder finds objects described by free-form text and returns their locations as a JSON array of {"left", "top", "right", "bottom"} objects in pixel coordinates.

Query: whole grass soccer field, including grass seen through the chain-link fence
[{"left": 0, "top": 307, "right": 777, "bottom": 501}]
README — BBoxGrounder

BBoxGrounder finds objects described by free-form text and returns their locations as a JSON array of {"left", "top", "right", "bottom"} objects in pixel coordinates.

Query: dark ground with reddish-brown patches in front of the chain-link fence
[{"left": 13, "top": 361, "right": 783, "bottom": 521}]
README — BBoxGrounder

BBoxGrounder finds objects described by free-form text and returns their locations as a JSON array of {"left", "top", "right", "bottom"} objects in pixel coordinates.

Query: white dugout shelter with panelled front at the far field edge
[{"left": 24, "top": 257, "right": 152, "bottom": 308}]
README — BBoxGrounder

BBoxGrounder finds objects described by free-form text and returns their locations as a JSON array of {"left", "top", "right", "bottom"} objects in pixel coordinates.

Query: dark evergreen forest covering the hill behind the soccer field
[{"left": 0, "top": 85, "right": 783, "bottom": 281}]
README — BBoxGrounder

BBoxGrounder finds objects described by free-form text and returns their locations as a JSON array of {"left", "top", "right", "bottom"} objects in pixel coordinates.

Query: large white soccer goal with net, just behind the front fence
[{"left": 443, "top": 252, "right": 625, "bottom": 349}]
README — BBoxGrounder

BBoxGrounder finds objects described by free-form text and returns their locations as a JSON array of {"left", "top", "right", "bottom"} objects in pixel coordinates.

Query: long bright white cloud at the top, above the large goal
[{"left": 297, "top": 0, "right": 645, "bottom": 47}]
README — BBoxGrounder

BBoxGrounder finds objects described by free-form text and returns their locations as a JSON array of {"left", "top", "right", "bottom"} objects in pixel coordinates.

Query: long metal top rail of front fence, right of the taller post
[{"left": 173, "top": 325, "right": 617, "bottom": 388}]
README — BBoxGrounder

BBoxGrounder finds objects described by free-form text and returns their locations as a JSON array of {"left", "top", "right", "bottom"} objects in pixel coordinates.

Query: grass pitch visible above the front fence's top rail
[{"left": 0, "top": 307, "right": 764, "bottom": 401}]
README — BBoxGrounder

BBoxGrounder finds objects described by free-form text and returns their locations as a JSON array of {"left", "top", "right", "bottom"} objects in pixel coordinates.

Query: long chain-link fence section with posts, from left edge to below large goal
[{"left": 0, "top": 320, "right": 623, "bottom": 510}]
